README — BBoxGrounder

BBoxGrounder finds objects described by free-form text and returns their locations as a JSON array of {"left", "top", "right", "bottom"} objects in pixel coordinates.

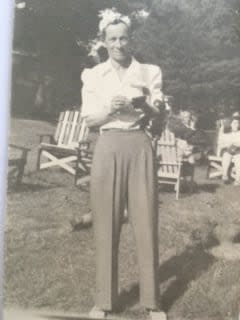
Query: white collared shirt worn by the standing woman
[{"left": 81, "top": 58, "right": 163, "bottom": 129}]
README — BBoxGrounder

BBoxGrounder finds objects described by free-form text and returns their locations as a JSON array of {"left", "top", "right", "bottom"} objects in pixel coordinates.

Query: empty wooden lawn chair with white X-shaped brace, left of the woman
[{"left": 37, "top": 111, "right": 89, "bottom": 180}]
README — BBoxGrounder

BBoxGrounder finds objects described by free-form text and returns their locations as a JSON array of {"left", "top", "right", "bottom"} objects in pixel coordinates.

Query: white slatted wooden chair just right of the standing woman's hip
[{"left": 156, "top": 127, "right": 194, "bottom": 200}]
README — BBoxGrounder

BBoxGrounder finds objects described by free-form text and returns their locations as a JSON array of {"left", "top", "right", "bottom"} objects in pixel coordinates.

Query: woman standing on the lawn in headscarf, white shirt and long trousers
[{"left": 82, "top": 9, "right": 166, "bottom": 319}]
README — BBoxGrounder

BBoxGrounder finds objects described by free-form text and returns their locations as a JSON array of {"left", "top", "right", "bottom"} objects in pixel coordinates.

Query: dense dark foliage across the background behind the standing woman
[{"left": 14, "top": 0, "right": 240, "bottom": 127}]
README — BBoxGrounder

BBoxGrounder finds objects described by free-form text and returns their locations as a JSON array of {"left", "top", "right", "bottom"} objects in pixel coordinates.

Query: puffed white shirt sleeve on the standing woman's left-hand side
[{"left": 81, "top": 69, "right": 101, "bottom": 117}]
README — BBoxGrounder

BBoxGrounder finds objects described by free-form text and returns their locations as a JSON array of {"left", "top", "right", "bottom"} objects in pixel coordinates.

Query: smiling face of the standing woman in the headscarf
[{"left": 104, "top": 22, "right": 130, "bottom": 62}]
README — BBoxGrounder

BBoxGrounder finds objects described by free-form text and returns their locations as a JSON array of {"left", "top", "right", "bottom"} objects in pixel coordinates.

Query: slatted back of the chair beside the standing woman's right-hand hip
[{"left": 156, "top": 128, "right": 180, "bottom": 178}]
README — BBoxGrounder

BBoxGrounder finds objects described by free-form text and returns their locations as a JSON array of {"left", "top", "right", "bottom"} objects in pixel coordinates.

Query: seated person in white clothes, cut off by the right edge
[{"left": 219, "top": 113, "right": 240, "bottom": 186}]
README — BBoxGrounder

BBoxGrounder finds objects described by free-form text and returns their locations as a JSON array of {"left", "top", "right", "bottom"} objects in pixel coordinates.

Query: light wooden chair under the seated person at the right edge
[{"left": 207, "top": 120, "right": 236, "bottom": 179}]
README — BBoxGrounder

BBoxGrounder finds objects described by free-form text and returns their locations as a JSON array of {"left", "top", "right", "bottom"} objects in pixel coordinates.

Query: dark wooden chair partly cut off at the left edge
[{"left": 8, "top": 144, "right": 30, "bottom": 185}]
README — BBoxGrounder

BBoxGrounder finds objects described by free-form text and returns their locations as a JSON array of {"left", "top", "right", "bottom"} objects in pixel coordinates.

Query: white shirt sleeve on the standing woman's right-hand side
[{"left": 149, "top": 66, "right": 164, "bottom": 105}]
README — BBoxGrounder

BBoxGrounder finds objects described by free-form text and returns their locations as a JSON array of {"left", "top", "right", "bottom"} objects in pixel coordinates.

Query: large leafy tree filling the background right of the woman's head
[{"left": 134, "top": 0, "right": 240, "bottom": 126}]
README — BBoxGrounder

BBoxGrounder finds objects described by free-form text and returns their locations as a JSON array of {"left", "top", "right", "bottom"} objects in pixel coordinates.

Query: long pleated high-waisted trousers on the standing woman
[{"left": 91, "top": 130, "right": 159, "bottom": 310}]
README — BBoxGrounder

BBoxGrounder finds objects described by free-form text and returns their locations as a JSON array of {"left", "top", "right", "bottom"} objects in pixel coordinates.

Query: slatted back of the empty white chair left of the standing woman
[{"left": 55, "top": 111, "right": 88, "bottom": 148}]
